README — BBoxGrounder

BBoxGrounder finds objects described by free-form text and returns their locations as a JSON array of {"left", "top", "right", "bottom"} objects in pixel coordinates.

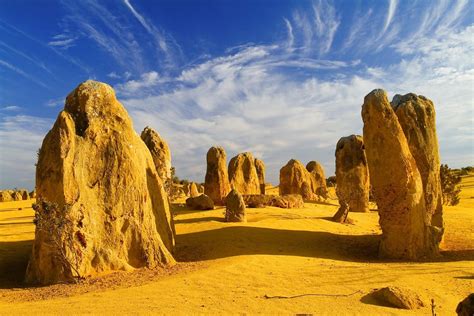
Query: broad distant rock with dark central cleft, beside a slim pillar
[{"left": 229, "top": 152, "right": 260, "bottom": 194}]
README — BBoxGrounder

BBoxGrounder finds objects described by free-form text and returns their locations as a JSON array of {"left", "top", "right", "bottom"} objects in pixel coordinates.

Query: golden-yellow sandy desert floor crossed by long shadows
[{"left": 0, "top": 175, "right": 474, "bottom": 315}]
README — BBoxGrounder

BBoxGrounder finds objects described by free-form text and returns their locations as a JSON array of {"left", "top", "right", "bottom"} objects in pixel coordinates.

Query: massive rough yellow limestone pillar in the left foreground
[{"left": 26, "top": 81, "right": 175, "bottom": 284}]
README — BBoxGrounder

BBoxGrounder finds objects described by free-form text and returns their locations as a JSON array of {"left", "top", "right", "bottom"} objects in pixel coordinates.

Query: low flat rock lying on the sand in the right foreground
[{"left": 371, "top": 286, "right": 425, "bottom": 309}]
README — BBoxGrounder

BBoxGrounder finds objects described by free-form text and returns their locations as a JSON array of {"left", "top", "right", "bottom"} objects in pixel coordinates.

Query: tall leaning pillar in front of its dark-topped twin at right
[{"left": 362, "top": 90, "right": 440, "bottom": 260}]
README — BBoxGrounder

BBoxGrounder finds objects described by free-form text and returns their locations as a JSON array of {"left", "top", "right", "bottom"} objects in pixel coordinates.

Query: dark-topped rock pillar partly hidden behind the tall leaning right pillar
[{"left": 392, "top": 93, "right": 444, "bottom": 229}]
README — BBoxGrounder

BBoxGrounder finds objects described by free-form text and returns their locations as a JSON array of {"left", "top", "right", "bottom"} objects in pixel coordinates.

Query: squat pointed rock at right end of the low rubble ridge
[{"left": 279, "top": 159, "right": 317, "bottom": 200}]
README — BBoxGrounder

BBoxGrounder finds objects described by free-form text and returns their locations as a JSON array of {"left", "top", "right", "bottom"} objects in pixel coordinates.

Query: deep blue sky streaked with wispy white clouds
[{"left": 0, "top": 0, "right": 474, "bottom": 189}]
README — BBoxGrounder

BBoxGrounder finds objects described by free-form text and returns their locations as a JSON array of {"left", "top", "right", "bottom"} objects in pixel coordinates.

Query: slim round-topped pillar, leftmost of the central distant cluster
[{"left": 204, "top": 147, "right": 230, "bottom": 205}]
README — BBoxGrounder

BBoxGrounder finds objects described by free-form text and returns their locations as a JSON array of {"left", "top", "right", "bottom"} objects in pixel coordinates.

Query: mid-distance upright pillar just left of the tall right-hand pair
[{"left": 336, "top": 135, "right": 370, "bottom": 212}]
